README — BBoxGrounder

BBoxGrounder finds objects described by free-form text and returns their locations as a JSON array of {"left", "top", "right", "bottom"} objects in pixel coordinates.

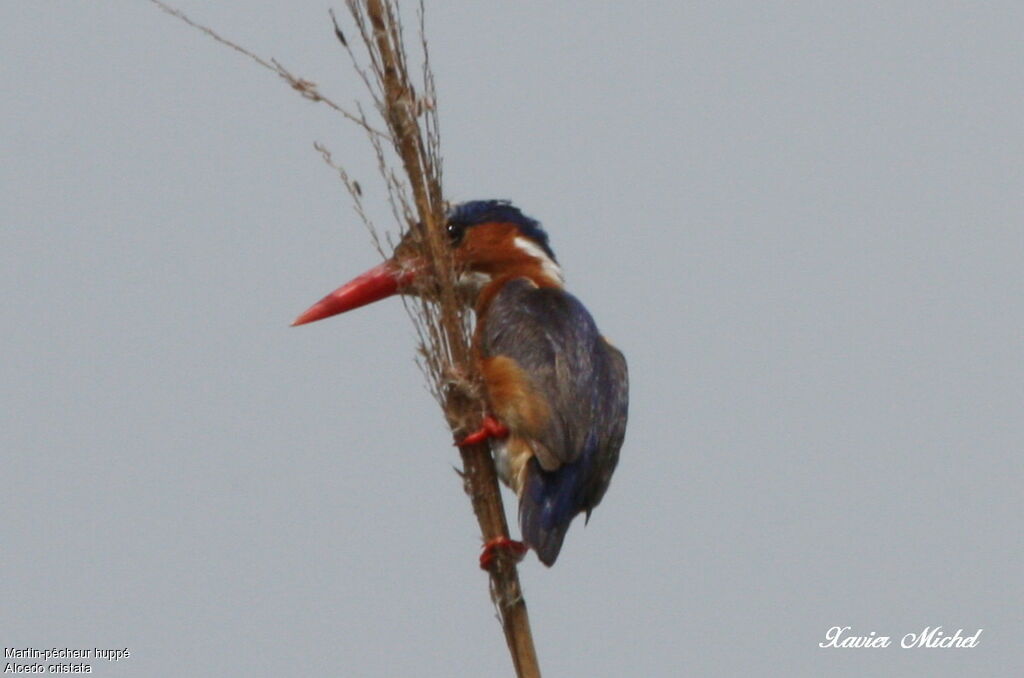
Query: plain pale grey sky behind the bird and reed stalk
[{"left": 0, "top": 0, "right": 1024, "bottom": 676}]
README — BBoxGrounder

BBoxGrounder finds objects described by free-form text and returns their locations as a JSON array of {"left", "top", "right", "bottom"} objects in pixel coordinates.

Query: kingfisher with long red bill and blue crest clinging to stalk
[{"left": 293, "top": 200, "right": 629, "bottom": 569}]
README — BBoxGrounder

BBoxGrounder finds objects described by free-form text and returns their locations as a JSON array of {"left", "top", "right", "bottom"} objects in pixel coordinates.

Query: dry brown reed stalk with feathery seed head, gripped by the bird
[{"left": 151, "top": 0, "right": 541, "bottom": 678}]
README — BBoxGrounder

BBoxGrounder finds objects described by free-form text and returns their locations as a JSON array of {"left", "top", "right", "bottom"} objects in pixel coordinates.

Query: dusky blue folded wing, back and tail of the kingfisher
[{"left": 480, "top": 279, "right": 629, "bottom": 565}]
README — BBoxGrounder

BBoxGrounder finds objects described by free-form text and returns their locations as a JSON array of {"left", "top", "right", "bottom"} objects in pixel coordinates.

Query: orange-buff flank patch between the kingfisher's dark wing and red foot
[{"left": 480, "top": 355, "right": 551, "bottom": 437}]
